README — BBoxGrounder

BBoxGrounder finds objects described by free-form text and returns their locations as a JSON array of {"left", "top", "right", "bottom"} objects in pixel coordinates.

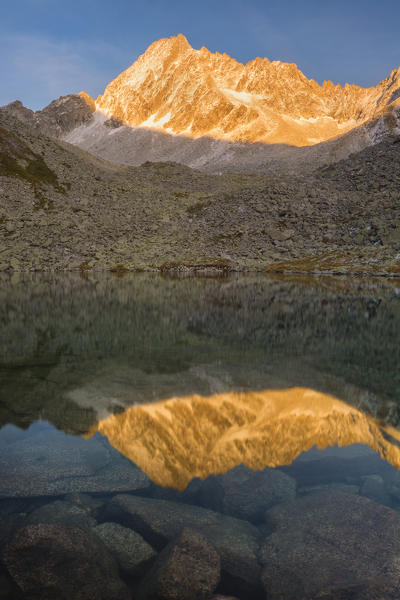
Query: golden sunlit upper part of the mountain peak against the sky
[{"left": 96, "top": 35, "right": 400, "bottom": 146}]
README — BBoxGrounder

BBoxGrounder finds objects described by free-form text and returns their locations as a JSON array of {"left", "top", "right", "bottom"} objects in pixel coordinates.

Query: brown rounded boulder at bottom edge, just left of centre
[{"left": 138, "top": 529, "right": 221, "bottom": 600}]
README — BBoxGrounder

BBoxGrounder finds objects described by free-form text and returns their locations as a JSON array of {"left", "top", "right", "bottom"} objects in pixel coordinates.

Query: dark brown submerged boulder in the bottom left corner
[{"left": 2, "top": 524, "right": 131, "bottom": 600}]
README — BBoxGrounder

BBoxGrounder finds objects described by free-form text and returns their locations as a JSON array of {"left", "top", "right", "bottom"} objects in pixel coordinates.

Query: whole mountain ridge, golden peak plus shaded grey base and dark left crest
[{"left": 0, "top": 35, "right": 400, "bottom": 174}]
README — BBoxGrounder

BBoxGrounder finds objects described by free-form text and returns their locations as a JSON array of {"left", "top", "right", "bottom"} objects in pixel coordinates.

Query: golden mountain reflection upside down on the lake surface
[{"left": 89, "top": 387, "right": 400, "bottom": 490}]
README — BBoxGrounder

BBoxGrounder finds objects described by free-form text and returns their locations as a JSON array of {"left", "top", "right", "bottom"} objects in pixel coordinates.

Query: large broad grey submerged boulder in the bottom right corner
[{"left": 259, "top": 493, "right": 400, "bottom": 600}]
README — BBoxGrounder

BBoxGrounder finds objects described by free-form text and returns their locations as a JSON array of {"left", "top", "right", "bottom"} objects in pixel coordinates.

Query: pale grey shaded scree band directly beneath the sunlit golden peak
[{"left": 64, "top": 108, "right": 400, "bottom": 175}]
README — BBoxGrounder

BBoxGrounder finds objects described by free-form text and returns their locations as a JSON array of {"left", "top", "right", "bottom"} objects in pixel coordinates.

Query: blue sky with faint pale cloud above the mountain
[{"left": 0, "top": 0, "right": 400, "bottom": 109}]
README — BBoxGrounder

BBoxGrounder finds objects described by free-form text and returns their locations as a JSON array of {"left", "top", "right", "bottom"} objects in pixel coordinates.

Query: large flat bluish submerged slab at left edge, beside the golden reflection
[{"left": 0, "top": 431, "right": 150, "bottom": 498}]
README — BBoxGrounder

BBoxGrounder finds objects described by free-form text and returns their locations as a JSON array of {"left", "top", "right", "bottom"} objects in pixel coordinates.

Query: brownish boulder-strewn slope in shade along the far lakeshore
[{"left": 0, "top": 112, "right": 400, "bottom": 274}]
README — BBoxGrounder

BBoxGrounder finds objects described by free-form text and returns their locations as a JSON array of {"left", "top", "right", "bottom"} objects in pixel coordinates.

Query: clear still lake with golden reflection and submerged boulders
[{"left": 0, "top": 275, "right": 400, "bottom": 600}]
